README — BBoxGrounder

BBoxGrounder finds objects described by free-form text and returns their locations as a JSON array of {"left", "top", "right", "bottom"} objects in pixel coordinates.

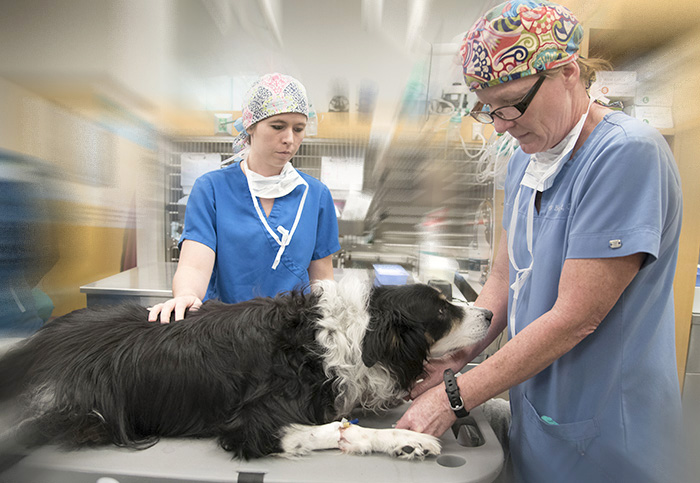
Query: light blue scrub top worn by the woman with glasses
[{"left": 503, "top": 112, "right": 681, "bottom": 483}]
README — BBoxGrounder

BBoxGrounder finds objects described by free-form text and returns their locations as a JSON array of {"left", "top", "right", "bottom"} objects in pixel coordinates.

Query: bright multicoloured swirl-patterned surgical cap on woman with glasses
[{"left": 460, "top": 0, "right": 583, "bottom": 91}]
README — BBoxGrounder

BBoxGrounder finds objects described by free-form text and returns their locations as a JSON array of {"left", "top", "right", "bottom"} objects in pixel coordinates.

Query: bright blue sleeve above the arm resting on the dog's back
[{"left": 179, "top": 176, "right": 216, "bottom": 251}]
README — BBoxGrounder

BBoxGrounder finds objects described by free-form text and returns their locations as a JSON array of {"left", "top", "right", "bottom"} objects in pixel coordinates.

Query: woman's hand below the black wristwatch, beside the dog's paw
[{"left": 396, "top": 385, "right": 457, "bottom": 438}]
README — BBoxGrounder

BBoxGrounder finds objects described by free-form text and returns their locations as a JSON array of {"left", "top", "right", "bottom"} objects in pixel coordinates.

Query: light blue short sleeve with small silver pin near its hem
[{"left": 566, "top": 136, "right": 672, "bottom": 263}]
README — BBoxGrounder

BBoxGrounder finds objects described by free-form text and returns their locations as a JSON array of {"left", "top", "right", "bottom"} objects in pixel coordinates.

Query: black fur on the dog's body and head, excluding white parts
[{"left": 0, "top": 285, "right": 476, "bottom": 458}]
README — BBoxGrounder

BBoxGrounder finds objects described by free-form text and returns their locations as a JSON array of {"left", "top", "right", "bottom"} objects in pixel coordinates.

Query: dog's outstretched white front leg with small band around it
[{"left": 281, "top": 422, "right": 440, "bottom": 459}]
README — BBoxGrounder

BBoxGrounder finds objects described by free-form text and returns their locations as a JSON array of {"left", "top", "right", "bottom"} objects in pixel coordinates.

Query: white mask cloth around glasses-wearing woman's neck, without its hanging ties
[{"left": 520, "top": 95, "right": 594, "bottom": 191}]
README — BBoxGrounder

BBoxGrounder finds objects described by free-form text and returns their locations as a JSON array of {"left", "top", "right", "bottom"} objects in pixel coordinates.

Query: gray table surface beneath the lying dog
[{"left": 0, "top": 406, "right": 503, "bottom": 483}]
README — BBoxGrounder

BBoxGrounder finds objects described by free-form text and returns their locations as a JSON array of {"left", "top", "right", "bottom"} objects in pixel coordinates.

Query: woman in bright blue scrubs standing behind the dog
[{"left": 149, "top": 73, "right": 340, "bottom": 322}]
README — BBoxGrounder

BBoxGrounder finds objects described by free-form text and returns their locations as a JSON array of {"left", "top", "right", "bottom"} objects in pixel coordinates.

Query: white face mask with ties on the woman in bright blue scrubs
[{"left": 241, "top": 159, "right": 309, "bottom": 270}]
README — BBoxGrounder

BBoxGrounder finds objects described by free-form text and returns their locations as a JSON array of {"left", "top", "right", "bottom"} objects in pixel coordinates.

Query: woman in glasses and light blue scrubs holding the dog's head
[{"left": 397, "top": 0, "right": 684, "bottom": 483}]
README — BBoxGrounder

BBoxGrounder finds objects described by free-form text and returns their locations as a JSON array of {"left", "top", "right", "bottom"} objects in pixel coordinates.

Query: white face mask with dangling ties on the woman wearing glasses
[{"left": 508, "top": 99, "right": 595, "bottom": 337}]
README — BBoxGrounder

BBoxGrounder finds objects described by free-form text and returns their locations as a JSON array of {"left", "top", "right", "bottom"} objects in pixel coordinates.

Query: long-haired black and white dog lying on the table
[{"left": 0, "top": 279, "right": 491, "bottom": 459}]
